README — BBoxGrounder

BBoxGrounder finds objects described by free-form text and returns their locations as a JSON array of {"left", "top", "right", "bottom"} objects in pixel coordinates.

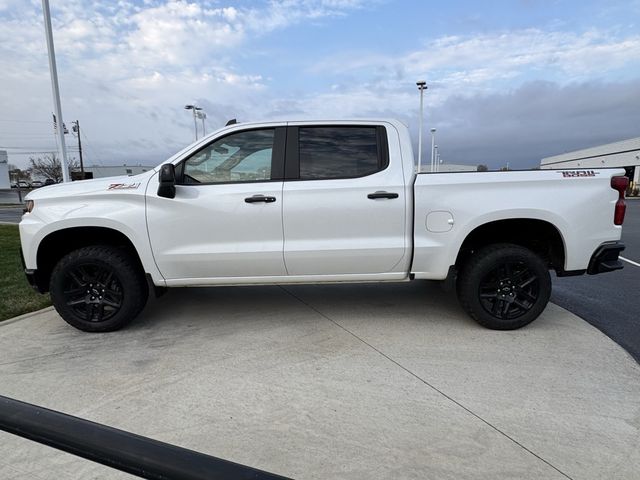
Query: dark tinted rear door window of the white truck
[{"left": 298, "top": 127, "right": 381, "bottom": 180}]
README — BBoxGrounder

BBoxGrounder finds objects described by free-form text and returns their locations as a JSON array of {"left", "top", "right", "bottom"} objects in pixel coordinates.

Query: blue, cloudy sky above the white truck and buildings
[{"left": 0, "top": 0, "right": 640, "bottom": 168}]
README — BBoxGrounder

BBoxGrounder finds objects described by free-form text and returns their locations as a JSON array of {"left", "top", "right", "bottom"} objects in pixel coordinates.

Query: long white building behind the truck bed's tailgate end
[{"left": 540, "top": 137, "right": 640, "bottom": 191}]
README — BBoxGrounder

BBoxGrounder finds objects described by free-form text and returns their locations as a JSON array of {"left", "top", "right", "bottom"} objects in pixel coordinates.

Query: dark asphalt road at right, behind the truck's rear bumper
[{"left": 551, "top": 200, "right": 640, "bottom": 362}]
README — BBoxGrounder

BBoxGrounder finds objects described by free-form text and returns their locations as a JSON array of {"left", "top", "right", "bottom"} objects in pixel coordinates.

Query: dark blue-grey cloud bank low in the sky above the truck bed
[{"left": 431, "top": 79, "right": 640, "bottom": 168}]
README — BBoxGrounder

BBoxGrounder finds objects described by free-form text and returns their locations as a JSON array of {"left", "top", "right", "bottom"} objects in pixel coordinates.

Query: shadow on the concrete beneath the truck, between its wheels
[{"left": 128, "top": 281, "right": 475, "bottom": 330}]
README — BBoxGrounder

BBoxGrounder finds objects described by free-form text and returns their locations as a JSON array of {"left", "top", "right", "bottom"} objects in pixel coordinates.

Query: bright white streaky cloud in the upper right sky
[{"left": 308, "top": 28, "right": 640, "bottom": 97}]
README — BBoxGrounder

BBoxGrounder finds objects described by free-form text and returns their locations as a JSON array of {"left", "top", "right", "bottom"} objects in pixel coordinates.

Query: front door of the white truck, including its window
[{"left": 147, "top": 127, "right": 286, "bottom": 283}]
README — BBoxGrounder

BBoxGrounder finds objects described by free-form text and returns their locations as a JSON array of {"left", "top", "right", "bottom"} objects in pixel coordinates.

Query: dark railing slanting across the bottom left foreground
[{"left": 0, "top": 395, "right": 285, "bottom": 480}]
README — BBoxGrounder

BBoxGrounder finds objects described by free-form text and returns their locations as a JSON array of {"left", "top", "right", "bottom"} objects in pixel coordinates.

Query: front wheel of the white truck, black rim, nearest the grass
[{"left": 49, "top": 246, "right": 149, "bottom": 332}]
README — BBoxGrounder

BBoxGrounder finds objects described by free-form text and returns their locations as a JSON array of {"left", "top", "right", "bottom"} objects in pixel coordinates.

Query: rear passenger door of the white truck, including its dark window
[{"left": 283, "top": 123, "right": 407, "bottom": 275}]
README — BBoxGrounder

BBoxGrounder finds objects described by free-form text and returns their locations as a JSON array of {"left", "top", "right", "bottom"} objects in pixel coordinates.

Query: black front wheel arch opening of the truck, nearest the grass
[{"left": 35, "top": 226, "right": 145, "bottom": 293}]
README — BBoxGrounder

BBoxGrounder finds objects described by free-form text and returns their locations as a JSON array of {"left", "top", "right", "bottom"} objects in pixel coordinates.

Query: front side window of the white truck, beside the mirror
[{"left": 183, "top": 129, "right": 274, "bottom": 183}]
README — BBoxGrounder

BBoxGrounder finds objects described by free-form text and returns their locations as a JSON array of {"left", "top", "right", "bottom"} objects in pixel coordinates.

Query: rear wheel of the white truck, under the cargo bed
[{"left": 458, "top": 244, "right": 551, "bottom": 330}]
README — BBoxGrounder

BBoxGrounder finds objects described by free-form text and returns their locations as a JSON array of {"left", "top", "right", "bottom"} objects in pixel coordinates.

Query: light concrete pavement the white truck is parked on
[{"left": 0, "top": 282, "right": 640, "bottom": 479}]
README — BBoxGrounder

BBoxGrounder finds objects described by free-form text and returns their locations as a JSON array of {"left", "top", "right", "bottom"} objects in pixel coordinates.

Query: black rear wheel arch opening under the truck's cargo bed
[{"left": 455, "top": 218, "right": 566, "bottom": 274}]
